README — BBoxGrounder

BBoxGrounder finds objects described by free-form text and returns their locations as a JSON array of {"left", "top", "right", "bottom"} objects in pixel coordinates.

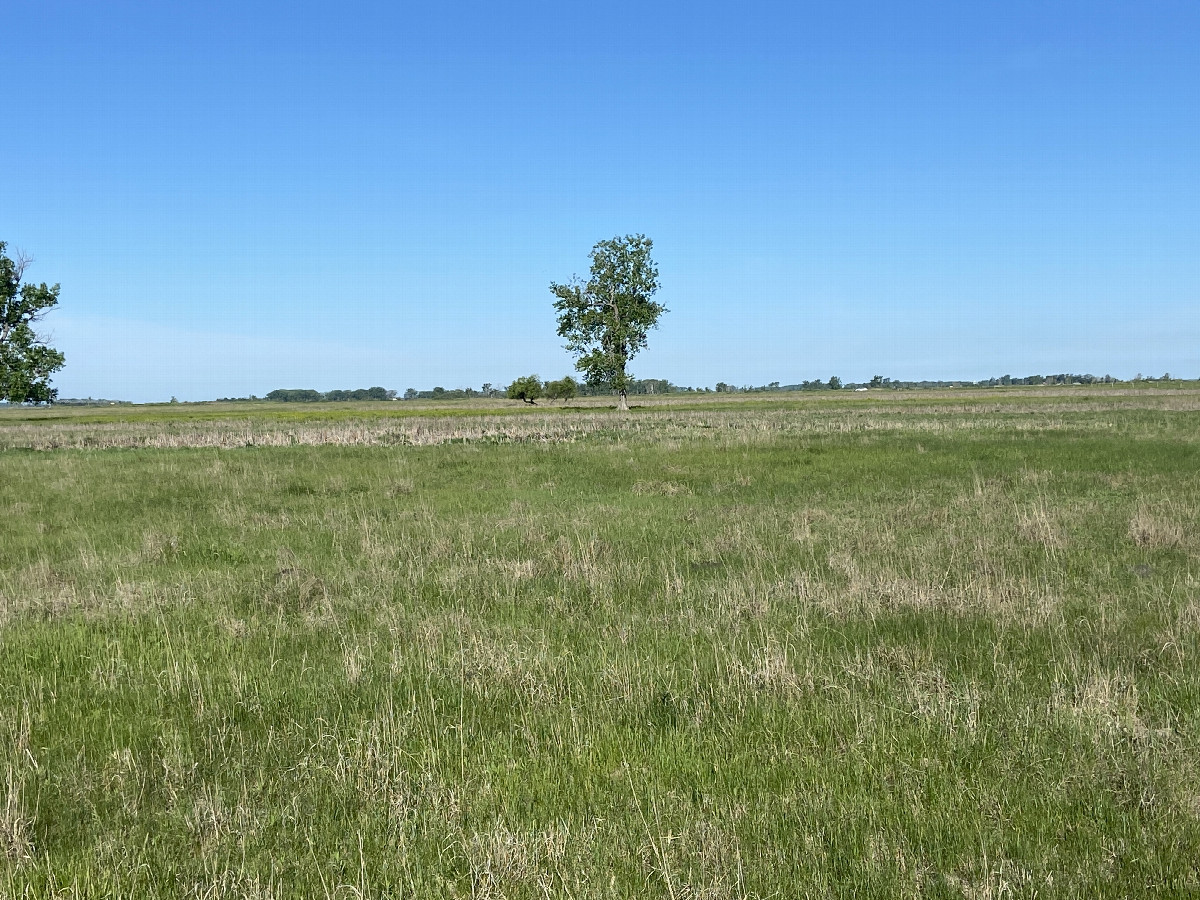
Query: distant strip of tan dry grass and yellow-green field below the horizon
[{"left": 7, "top": 382, "right": 1200, "bottom": 450}]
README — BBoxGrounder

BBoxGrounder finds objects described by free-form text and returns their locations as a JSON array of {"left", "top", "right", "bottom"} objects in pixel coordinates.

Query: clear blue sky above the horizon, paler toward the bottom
[{"left": 0, "top": 0, "right": 1200, "bottom": 401}]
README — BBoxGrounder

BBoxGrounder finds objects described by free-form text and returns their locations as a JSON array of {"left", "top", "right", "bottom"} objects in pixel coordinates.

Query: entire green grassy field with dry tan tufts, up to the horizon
[{"left": 0, "top": 388, "right": 1200, "bottom": 899}]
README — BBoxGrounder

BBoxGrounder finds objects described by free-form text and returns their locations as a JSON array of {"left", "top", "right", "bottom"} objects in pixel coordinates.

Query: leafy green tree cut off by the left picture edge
[{"left": 0, "top": 241, "right": 64, "bottom": 403}]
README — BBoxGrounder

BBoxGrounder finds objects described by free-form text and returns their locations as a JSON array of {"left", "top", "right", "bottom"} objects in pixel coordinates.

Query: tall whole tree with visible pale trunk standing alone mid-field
[{"left": 550, "top": 234, "right": 667, "bottom": 409}]
